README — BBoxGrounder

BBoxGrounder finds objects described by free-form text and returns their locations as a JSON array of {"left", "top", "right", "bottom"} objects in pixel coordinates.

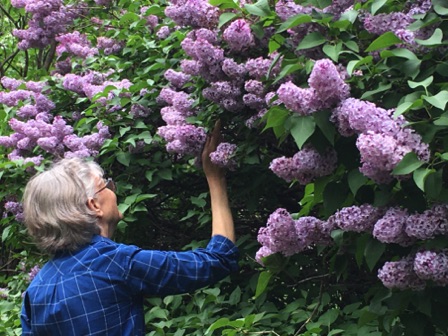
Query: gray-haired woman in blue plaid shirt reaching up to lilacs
[{"left": 21, "top": 122, "right": 238, "bottom": 336}]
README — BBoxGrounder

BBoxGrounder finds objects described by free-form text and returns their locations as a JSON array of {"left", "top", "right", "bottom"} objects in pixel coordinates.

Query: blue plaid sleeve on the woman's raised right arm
[{"left": 126, "top": 235, "right": 238, "bottom": 295}]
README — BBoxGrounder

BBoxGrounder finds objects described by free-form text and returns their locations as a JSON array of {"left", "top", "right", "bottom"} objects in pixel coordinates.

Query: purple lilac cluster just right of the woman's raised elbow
[{"left": 256, "top": 208, "right": 327, "bottom": 264}]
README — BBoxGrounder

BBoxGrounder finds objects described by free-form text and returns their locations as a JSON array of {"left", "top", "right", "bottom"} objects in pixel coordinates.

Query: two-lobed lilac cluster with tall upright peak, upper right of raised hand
[{"left": 277, "top": 59, "right": 350, "bottom": 115}]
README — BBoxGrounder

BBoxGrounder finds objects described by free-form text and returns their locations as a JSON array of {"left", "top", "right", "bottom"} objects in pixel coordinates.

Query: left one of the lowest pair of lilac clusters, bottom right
[{"left": 378, "top": 258, "right": 425, "bottom": 290}]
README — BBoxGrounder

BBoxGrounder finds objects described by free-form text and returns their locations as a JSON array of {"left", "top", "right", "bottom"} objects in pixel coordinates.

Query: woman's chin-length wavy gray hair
[{"left": 23, "top": 158, "right": 104, "bottom": 254}]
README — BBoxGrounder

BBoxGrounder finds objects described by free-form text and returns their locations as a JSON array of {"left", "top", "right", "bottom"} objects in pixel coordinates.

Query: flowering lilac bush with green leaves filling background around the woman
[{"left": 0, "top": 0, "right": 448, "bottom": 336}]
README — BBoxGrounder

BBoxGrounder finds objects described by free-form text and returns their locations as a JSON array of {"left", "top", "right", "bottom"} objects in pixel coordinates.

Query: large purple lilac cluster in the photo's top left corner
[{"left": 11, "top": 0, "right": 79, "bottom": 49}]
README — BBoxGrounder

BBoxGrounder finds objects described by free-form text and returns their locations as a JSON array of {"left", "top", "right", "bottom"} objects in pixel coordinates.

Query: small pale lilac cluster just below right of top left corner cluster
[{"left": 56, "top": 31, "right": 98, "bottom": 58}]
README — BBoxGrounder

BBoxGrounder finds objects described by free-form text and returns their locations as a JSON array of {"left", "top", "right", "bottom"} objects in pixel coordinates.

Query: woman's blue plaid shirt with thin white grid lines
[{"left": 21, "top": 236, "right": 238, "bottom": 336}]
